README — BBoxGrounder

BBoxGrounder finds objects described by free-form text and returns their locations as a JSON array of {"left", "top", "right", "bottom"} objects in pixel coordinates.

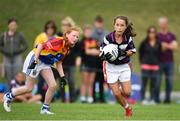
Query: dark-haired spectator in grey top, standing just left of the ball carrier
[{"left": 92, "top": 15, "right": 108, "bottom": 102}]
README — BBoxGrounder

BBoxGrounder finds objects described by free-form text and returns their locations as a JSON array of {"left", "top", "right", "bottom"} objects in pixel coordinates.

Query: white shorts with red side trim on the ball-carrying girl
[{"left": 103, "top": 61, "right": 131, "bottom": 83}]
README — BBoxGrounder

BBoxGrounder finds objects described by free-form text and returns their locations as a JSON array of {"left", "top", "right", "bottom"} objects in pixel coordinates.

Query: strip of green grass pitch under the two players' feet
[{"left": 0, "top": 103, "right": 180, "bottom": 120}]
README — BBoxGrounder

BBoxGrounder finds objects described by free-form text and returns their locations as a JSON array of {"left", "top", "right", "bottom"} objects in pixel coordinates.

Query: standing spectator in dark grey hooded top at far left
[{"left": 0, "top": 18, "right": 28, "bottom": 90}]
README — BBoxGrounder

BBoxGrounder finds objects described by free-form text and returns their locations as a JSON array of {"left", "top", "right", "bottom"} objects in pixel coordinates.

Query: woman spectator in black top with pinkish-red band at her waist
[{"left": 139, "top": 26, "right": 161, "bottom": 104}]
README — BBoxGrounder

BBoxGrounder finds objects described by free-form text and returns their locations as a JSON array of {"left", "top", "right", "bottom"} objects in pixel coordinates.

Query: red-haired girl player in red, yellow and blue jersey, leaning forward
[{"left": 4, "top": 27, "right": 80, "bottom": 114}]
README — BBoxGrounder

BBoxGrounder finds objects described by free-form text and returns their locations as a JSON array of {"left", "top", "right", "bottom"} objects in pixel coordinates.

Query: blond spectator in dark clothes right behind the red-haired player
[{"left": 57, "top": 16, "right": 77, "bottom": 102}]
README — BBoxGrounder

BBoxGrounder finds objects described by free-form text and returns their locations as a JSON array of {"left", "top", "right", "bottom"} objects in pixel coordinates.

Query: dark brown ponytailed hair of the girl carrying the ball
[{"left": 113, "top": 16, "right": 136, "bottom": 37}]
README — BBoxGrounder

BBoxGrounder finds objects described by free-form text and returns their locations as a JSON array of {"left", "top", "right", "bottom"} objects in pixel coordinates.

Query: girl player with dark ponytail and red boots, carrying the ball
[{"left": 100, "top": 16, "right": 136, "bottom": 117}]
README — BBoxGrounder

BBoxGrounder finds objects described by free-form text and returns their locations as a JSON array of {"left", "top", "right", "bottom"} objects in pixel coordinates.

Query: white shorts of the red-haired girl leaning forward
[{"left": 23, "top": 51, "right": 51, "bottom": 78}]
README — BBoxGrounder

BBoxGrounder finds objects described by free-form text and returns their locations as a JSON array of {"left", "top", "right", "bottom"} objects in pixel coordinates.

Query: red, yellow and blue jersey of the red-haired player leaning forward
[{"left": 33, "top": 33, "right": 69, "bottom": 65}]
